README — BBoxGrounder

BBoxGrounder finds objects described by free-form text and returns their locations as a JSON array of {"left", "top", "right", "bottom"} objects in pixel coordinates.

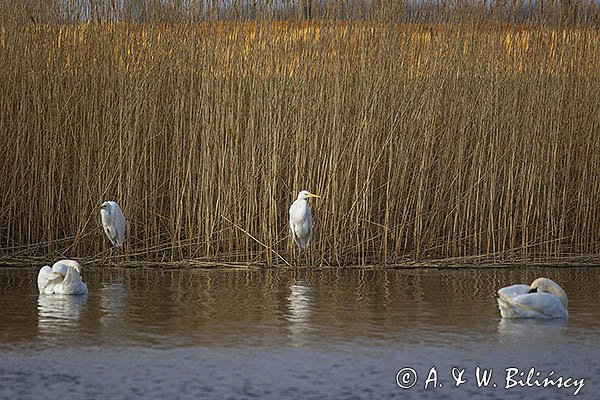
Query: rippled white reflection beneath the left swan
[{"left": 38, "top": 294, "right": 87, "bottom": 341}]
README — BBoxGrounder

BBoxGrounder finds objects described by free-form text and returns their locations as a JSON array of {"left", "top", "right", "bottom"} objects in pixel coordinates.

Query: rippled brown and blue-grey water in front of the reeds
[{"left": 0, "top": 267, "right": 600, "bottom": 399}]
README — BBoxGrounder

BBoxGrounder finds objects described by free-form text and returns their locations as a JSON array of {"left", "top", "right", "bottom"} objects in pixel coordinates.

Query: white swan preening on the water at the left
[{"left": 38, "top": 260, "right": 88, "bottom": 294}]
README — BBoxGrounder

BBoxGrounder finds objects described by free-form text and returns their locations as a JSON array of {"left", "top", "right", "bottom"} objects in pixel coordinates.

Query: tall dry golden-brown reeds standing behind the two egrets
[{"left": 0, "top": 20, "right": 600, "bottom": 265}]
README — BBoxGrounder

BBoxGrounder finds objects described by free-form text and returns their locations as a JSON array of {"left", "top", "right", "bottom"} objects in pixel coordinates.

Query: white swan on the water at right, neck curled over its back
[{"left": 498, "top": 278, "right": 569, "bottom": 318}]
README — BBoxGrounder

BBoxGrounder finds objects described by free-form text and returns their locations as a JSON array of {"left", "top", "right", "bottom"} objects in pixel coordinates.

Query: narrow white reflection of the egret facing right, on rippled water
[{"left": 287, "top": 281, "right": 313, "bottom": 346}]
